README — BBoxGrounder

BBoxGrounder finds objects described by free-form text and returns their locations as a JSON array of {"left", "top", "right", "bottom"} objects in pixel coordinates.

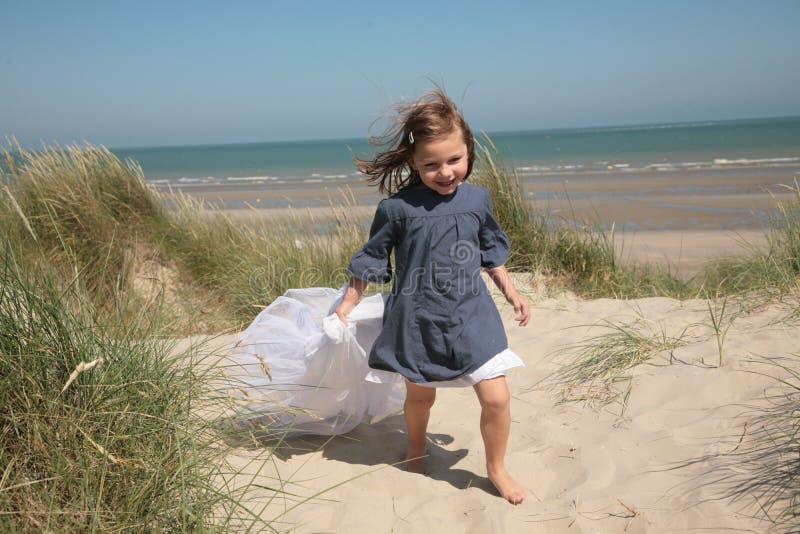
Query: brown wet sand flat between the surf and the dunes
[{"left": 162, "top": 166, "right": 800, "bottom": 230}]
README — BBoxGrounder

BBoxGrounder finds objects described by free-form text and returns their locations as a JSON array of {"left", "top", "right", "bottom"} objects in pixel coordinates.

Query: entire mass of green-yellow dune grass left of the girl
[{"left": 0, "top": 141, "right": 382, "bottom": 532}]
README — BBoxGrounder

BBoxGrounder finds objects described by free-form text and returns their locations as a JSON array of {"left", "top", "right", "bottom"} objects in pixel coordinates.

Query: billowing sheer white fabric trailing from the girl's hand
[{"left": 226, "top": 286, "right": 405, "bottom": 435}]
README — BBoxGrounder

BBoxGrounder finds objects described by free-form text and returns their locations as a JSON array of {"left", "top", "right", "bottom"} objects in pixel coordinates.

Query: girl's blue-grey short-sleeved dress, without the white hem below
[{"left": 348, "top": 182, "right": 509, "bottom": 383}]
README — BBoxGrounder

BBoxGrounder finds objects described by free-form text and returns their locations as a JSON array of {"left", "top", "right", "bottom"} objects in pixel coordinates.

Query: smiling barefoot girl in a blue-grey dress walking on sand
[{"left": 334, "top": 90, "right": 529, "bottom": 504}]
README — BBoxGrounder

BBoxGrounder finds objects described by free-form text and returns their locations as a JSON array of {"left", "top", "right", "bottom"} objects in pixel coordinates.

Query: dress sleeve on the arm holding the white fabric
[{"left": 347, "top": 200, "right": 395, "bottom": 284}]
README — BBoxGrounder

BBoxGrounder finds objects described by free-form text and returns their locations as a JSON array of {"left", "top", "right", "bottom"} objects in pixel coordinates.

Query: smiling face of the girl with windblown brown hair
[{"left": 409, "top": 128, "right": 469, "bottom": 195}]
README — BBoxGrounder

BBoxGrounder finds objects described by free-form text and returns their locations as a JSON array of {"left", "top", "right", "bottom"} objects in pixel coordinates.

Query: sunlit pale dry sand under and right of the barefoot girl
[{"left": 202, "top": 293, "right": 798, "bottom": 534}]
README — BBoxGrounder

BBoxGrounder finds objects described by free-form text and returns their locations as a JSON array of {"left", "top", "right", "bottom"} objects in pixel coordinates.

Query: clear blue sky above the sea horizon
[{"left": 0, "top": 0, "right": 800, "bottom": 147}]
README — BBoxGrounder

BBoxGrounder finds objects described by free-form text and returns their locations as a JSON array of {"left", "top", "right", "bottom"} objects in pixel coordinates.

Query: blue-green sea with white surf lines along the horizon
[{"left": 111, "top": 117, "right": 800, "bottom": 187}]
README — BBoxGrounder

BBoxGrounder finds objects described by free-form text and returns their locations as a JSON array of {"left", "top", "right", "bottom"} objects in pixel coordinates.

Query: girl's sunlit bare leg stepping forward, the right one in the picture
[{"left": 474, "top": 376, "right": 525, "bottom": 504}]
